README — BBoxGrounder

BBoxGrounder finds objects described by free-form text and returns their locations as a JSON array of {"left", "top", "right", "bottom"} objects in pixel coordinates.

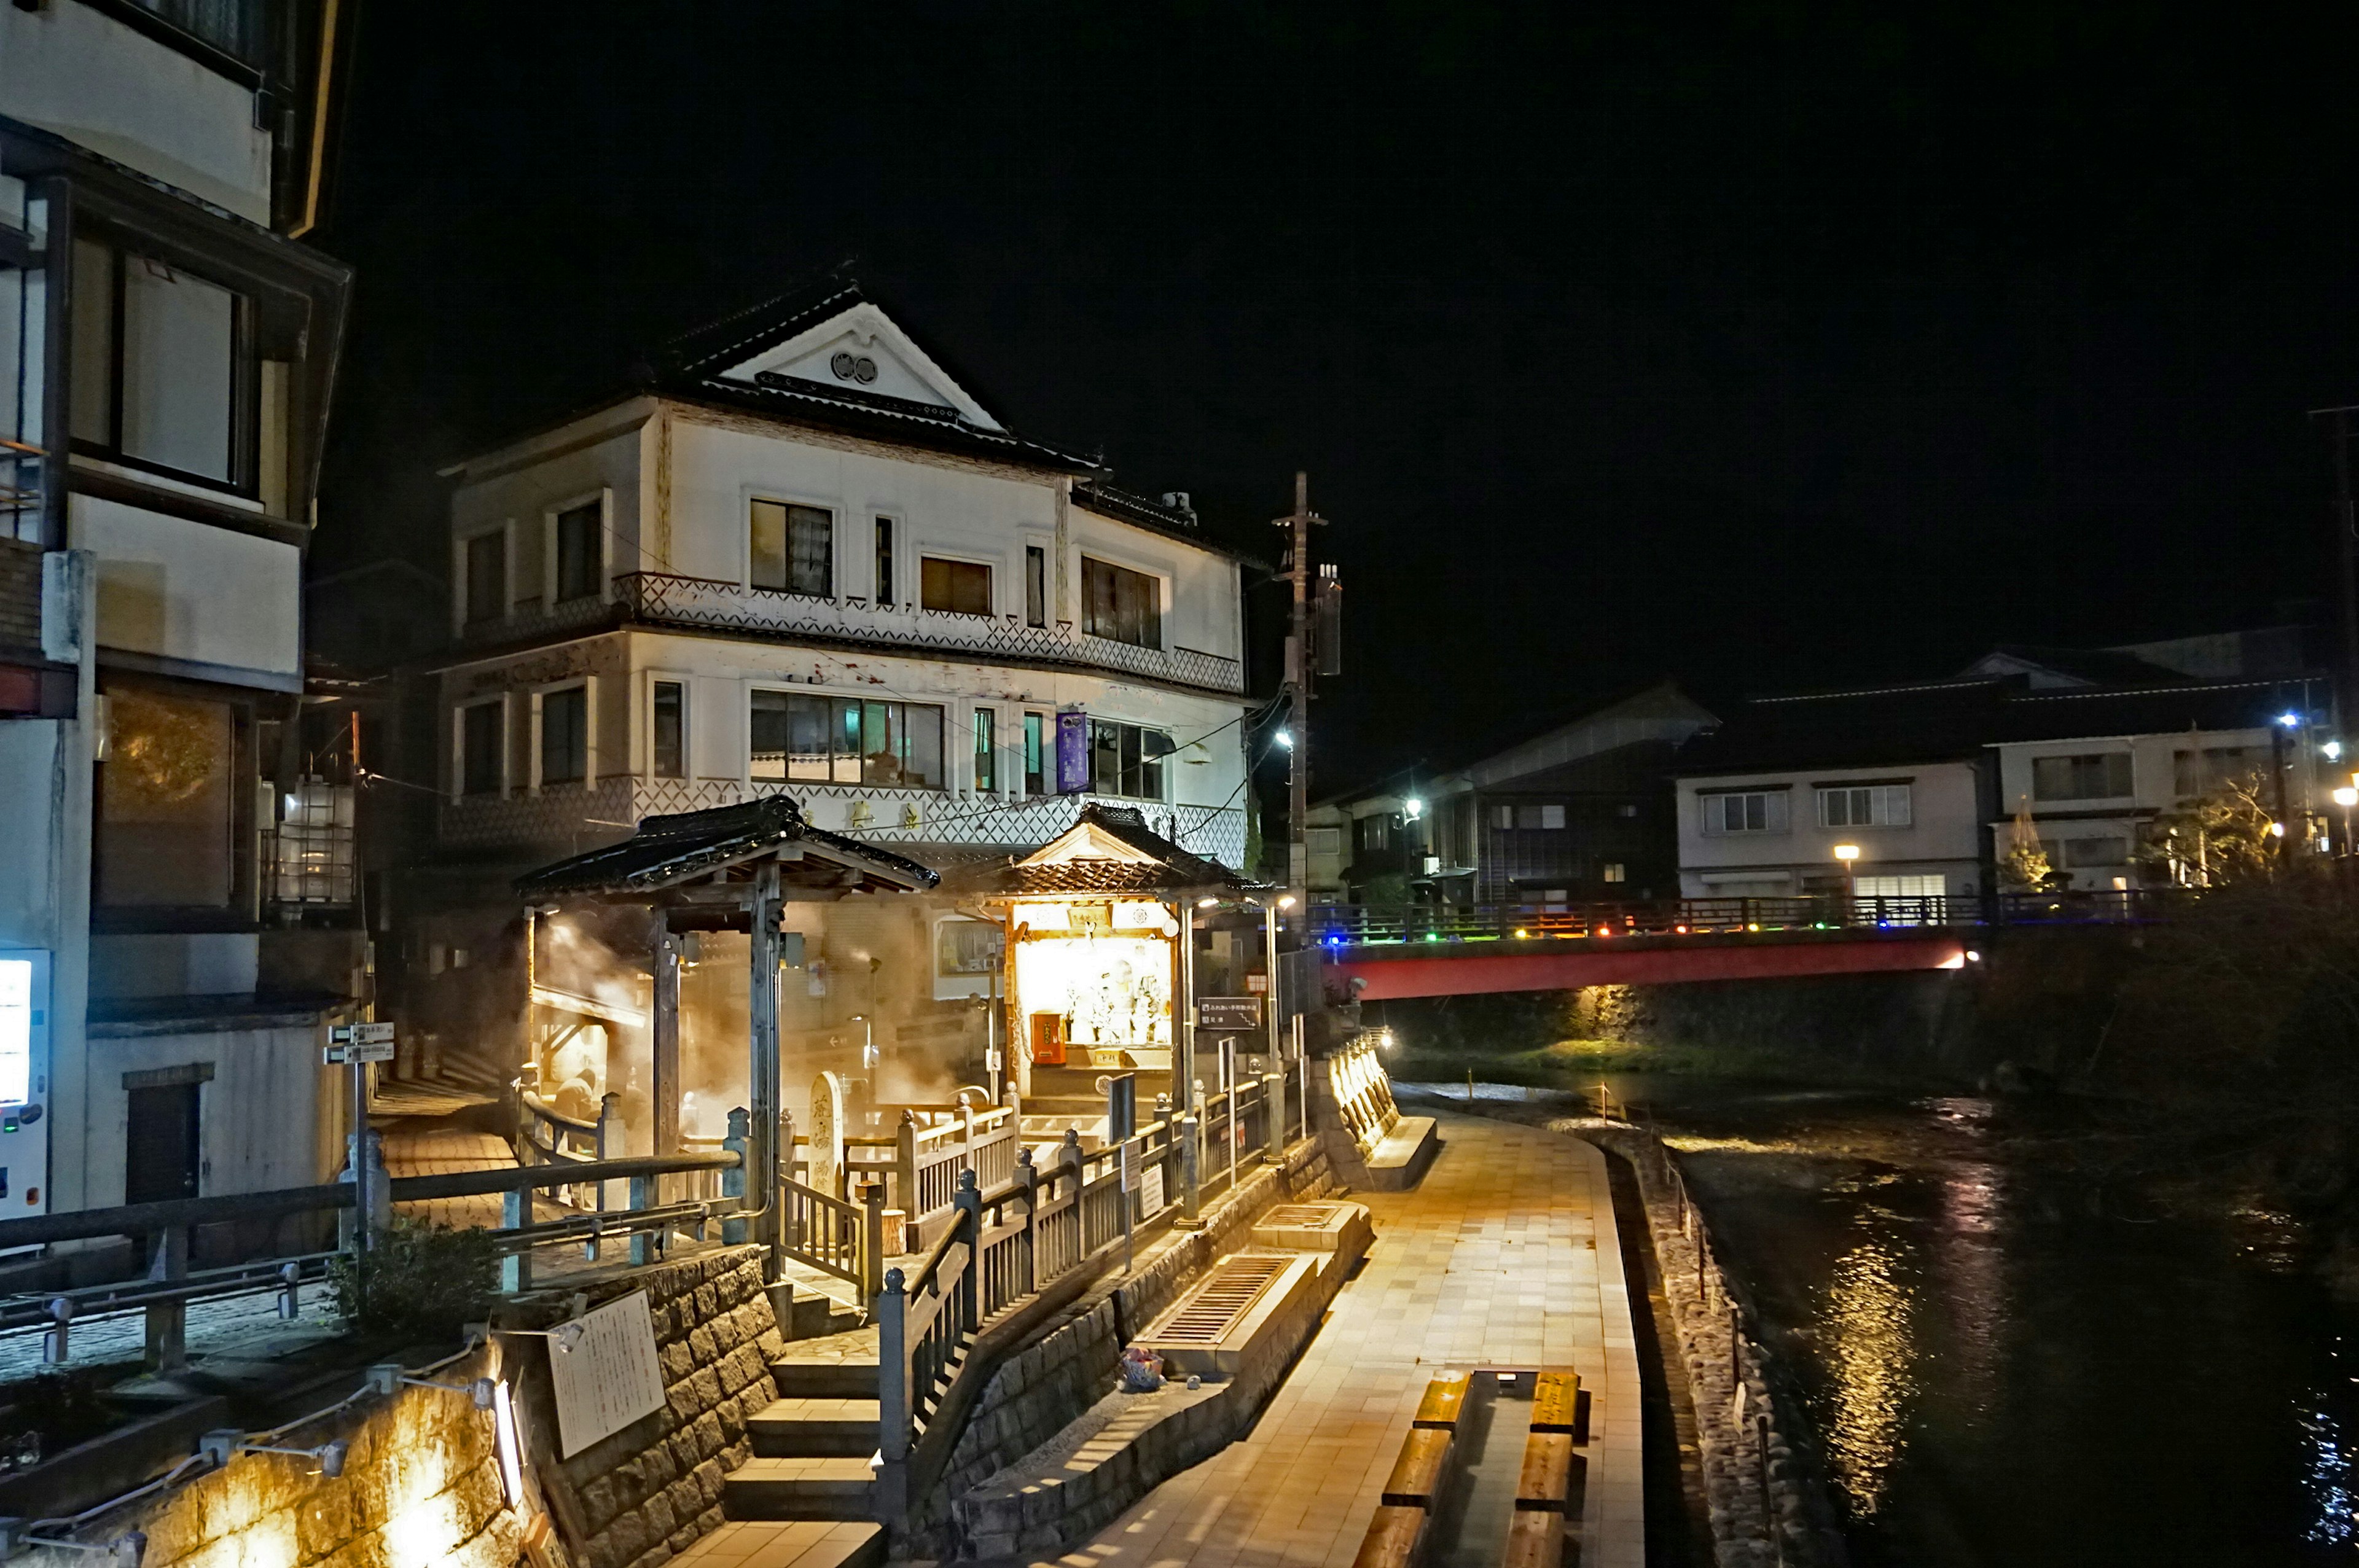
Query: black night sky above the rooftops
[{"left": 314, "top": 0, "right": 2359, "bottom": 785}]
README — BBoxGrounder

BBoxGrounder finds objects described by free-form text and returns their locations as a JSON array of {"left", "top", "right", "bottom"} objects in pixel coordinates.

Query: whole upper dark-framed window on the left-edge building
[{"left": 71, "top": 238, "right": 255, "bottom": 486}]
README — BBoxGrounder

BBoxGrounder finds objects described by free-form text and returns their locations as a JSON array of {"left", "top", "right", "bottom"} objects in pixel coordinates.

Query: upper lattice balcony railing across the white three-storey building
[{"left": 448, "top": 571, "right": 1246, "bottom": 693}]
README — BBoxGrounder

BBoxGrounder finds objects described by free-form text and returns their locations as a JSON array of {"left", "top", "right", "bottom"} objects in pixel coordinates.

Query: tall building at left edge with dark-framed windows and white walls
[{"left": 0, "top": 0, "right": 359, "bottom": 1217}]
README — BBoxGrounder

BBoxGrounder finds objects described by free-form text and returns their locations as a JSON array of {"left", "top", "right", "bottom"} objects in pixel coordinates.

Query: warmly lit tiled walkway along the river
[{"left": 1059, "top": 1115, "right": 1644, "bottom": 1568}]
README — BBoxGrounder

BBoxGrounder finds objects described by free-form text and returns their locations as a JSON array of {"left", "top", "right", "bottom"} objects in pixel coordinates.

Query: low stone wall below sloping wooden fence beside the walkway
[{"left": 913, "top": 1139, "right": 1335, "bottom": 1556}]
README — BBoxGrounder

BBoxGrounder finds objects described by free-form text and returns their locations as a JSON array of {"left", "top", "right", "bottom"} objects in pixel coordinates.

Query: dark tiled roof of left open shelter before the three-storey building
[{"left": 517, "top": 795, "right": 941, "bottom": 899}]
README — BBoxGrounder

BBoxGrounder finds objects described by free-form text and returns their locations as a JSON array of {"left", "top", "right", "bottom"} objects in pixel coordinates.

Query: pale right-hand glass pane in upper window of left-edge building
[{"left": 118, "top": 257, "right": 238, "bottom": 481}]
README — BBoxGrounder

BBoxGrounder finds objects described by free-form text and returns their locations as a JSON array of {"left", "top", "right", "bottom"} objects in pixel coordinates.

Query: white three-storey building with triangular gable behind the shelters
[{"left": 408, "top": 278, "right": 1248, "bottom": 1089}]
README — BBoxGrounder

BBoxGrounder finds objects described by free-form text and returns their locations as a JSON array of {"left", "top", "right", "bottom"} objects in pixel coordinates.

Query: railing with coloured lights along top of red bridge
[{"left": 1309, "top": 889, "right": 2185, "bottom": 945}]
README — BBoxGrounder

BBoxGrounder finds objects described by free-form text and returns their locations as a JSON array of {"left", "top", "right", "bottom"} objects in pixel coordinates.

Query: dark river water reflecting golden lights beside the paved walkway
[{"left": 1609, "top": 1075, "right": 2359, "bottom": 1568}]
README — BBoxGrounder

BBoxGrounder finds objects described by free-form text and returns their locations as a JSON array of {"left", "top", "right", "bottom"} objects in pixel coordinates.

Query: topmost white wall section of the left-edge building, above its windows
[{"left": 0, "top": 0, "right": 272, "bottom": 224}]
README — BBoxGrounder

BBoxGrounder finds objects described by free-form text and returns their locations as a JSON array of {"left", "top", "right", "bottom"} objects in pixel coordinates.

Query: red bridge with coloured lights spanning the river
[{"left": 1309, "top": 889, "right": 2175, "bottom": 1002}]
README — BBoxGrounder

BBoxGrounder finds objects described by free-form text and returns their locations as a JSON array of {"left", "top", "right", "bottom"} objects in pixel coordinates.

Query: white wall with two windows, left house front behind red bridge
[{"left": 1680, "top": 762, "right": 1982, "bottom": 899}]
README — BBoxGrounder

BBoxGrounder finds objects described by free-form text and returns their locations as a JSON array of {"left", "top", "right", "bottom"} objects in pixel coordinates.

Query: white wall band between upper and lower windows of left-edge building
[{"left": 68, "top": 495, "right": 302, "bottom": 691}]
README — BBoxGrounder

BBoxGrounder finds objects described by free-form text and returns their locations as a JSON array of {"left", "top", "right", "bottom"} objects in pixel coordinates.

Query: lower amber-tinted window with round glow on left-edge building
[{"left": 96, "top": 688, "right": 235, "bottom": 908}]
